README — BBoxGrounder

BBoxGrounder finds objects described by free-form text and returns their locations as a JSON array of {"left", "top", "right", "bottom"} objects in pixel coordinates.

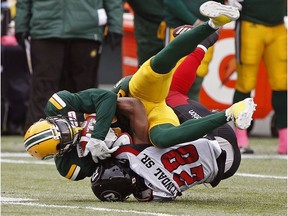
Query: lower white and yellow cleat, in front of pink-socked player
[{"left": 225, "top": 98, "right": 256, "bottom": 130}]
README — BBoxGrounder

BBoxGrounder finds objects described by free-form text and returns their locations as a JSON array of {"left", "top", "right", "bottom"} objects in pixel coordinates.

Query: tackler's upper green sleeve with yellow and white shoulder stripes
[{"left": 44, "top": 89, "right": 117, "bottom": 140}]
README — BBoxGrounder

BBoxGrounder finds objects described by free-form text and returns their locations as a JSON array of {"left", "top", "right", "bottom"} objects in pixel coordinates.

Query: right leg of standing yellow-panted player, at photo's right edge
[{"left": 264, "top": 25, "right": 287, "bottom": 154}]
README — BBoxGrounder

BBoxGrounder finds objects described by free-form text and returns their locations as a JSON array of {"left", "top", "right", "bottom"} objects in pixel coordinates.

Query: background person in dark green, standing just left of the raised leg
[{"left": 127, "top": 0, "right": 165, "bottom": 66}]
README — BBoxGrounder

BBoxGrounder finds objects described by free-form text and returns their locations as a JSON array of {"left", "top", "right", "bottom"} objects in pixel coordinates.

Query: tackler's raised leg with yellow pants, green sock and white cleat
[{"left": 129, "top": 2, "right": 239, "bottom": 102}]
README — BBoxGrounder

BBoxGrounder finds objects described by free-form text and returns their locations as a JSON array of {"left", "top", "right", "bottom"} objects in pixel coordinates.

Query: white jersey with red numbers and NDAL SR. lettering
[{"left": 114, "top": 138, "right": 221, "bottom": 200}]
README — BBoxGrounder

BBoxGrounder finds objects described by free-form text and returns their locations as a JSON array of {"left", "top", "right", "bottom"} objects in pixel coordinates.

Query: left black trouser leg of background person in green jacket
[{"left": 24, "top": 39, "right": 65, "bottom": 131}]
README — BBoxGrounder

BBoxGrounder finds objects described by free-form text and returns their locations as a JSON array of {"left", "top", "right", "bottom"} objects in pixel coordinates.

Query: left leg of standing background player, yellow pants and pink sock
[{"left": 233, "top": 21, "right": 264, "bottom": 153}]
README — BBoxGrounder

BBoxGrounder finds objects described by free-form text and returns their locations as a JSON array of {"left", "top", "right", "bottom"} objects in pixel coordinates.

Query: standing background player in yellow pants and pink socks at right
[{"left": 228, "top": 0, "right": 287, "bottom": 154}]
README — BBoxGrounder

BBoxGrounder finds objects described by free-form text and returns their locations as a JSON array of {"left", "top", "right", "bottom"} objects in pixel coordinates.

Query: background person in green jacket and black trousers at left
[{"left": 16, "top": 0, "right": 123, "bottom": 130}]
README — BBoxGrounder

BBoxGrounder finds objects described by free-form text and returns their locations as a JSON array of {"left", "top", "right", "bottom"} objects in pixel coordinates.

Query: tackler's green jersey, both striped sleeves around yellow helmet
[{"left": 44, "top": 89, "right": 117, "bottom": 181}]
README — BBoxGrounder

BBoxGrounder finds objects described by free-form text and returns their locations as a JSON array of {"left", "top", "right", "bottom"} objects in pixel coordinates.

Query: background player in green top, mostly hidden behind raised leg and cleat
[{"left": 163, "top": 0, "right": 224, "bottom": 101}]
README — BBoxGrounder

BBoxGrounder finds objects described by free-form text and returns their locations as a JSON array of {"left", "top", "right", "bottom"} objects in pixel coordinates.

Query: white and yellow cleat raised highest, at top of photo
[{"left": 199, "top": 1, "right": 240, "bottom": 28}]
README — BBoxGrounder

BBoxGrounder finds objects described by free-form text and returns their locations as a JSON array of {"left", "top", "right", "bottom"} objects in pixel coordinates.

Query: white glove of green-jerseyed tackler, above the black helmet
[{"left": 84, "top": 138, "right": 119, "bottom": 163}]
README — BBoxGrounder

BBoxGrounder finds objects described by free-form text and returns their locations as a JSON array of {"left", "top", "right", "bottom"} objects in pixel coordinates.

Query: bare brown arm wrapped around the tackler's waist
[{"left": 117, "top": 97, "right": 150, "bottom": 144}]
